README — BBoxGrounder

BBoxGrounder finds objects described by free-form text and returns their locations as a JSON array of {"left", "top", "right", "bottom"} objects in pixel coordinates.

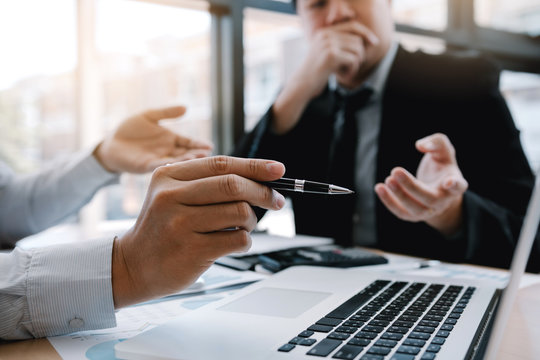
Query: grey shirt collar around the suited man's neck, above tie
[{"left": 328, "top": 41, "right": 398, "bottom": 97}]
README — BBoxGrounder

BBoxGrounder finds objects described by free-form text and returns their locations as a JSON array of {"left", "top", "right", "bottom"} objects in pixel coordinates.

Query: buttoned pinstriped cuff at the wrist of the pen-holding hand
[{"left": 27, "top": 239, "right": 116, "bottom": 337}]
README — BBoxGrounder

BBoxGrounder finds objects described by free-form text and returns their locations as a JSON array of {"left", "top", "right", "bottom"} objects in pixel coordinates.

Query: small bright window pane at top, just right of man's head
[{"left": 392, "top": 0, "right": 449, "bottom": 31}]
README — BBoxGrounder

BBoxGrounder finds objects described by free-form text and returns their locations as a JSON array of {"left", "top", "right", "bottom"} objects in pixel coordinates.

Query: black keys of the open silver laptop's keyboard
[{"left": 278, "top": 280, "right": 475, "bottom": 360}]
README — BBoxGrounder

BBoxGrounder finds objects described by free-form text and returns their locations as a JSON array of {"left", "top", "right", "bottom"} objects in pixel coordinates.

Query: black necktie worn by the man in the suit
[{"left": 328, "top": 87, "right": 373, "bottom": 189}]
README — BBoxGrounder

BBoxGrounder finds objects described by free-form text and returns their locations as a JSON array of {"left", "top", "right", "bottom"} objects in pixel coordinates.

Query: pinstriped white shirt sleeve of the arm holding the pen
[{"left": 0, "top": 239, "right": 116, "bottom": 340}]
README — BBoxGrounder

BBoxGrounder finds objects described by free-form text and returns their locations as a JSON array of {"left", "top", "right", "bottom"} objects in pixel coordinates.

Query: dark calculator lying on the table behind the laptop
[{"left": 258, "top": 247, "right": 388, "bottom": 272}]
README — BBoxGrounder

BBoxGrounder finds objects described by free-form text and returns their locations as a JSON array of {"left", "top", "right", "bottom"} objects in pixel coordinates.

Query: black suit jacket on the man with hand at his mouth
[{"left": 234, "top": 48, "right": 540, "bottom": 271}]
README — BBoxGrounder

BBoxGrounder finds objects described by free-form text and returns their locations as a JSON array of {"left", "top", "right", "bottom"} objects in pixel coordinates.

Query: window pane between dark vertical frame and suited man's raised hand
[{"left": 244, "top": 9, "right": 305, "bottom": 131}]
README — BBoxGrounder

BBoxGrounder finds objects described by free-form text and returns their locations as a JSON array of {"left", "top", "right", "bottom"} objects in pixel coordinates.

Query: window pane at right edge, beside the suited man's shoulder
[{"left": 501, "top": 71, "right": 540, "bottom": 170}]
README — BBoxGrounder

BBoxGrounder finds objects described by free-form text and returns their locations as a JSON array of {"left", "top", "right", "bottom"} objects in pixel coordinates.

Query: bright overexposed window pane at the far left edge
[{"left": 0, "top": 0, "right": 77, "bottom": 172}]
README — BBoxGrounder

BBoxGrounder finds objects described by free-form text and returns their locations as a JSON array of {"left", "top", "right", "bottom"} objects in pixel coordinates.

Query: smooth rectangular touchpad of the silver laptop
[{"left": 217, "top": 288, "right": 331, "bottom": 318}]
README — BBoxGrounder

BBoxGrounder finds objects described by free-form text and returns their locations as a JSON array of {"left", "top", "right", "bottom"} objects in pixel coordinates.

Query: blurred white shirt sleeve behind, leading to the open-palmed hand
[{"left": 0, "top": 153, "right": 118, "bottom": 248}]
